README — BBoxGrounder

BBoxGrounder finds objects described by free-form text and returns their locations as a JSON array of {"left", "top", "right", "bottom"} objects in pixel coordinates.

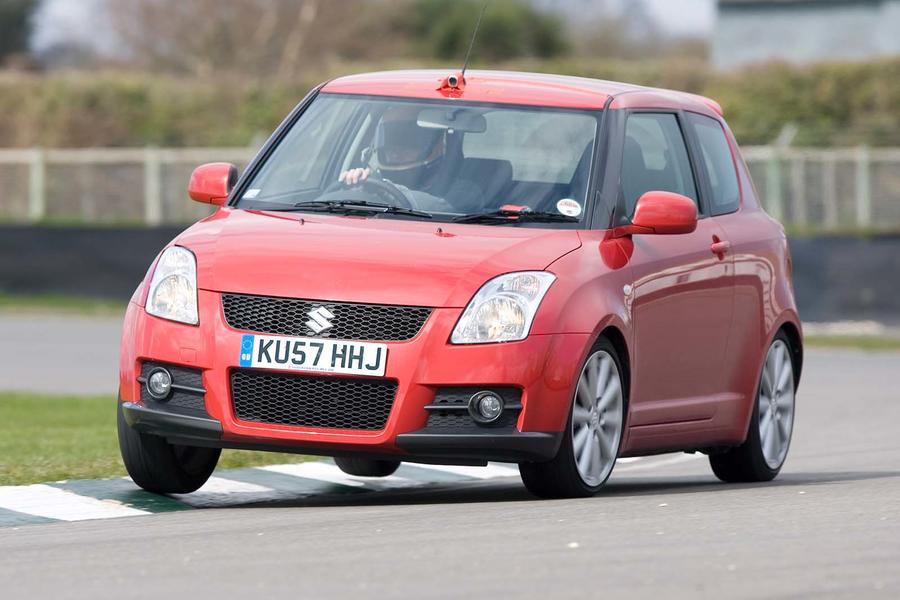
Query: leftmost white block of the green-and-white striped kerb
[{"left": 0, "top": 484, "right": 151, "bottom": 521}]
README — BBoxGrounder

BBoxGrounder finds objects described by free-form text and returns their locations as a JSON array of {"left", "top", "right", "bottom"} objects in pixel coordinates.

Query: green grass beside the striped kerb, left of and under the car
[{"left": 0, "top": 393, "right": 310, "bottom": 485}]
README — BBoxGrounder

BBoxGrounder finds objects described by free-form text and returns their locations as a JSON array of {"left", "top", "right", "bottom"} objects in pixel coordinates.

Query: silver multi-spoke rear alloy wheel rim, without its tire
[{"left": 758, "top": 340, "right": 795, "bottom": 469}]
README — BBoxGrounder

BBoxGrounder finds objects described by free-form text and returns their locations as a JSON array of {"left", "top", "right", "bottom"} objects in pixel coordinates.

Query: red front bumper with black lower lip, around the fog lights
[{"left": 119, "top": 290, "right": 590, "bottom": 463}]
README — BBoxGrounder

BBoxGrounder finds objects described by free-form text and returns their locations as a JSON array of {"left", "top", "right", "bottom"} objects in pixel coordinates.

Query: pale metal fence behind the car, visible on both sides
[{"left": 0, "top": 146, "right": 900, "bottom": 230}]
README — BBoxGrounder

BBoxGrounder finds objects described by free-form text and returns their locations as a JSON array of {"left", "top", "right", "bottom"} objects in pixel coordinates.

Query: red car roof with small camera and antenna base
[{"left": 322, "top": 70, "right": 721, "bottom": 114}]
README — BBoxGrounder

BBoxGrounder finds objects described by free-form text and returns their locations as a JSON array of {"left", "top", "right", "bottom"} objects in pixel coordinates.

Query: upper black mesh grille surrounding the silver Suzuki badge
[{"left": 222, "top": 294, "right": 431, "bottom": 342}]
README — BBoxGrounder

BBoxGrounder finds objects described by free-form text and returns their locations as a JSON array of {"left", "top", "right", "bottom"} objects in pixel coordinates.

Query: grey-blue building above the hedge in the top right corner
[{"left": 712, "top": 0, "right": 900, "bottom": 68}]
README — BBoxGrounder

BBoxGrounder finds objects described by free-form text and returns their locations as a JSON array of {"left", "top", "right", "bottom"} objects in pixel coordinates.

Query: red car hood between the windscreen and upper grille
[{"left": 175, "top": 208, "right": 581, "bottom": 307}]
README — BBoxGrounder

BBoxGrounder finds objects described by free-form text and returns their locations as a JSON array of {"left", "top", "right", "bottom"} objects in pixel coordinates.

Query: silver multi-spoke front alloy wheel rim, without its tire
[{"left": 572, "top": 350, "right": 624, "bottom": 486}]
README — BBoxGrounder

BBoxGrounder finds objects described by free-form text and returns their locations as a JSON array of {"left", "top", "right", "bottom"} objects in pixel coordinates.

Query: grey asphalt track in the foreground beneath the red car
[{"left": 0, "top": 328, "right": 900, "bottom": 600}]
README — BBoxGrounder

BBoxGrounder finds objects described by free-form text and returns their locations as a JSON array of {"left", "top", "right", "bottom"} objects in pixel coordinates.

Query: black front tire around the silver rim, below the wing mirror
[{"left": 519, "top": 338, "right": 628, "bottom": 498}]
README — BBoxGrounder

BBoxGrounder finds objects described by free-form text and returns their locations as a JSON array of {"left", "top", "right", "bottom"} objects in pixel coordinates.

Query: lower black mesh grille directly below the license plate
[{"left": 231, "top": 370, "right": 397, "bottom": 431}]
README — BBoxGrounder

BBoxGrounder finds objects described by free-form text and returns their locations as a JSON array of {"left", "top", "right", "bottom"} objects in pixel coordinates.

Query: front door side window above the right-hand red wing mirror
[{"left": 622, "top": 113, "right": 697, "bottom": 216}]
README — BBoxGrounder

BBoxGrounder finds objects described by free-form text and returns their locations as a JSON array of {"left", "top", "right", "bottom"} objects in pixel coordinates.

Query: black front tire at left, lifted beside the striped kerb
[{"left": 117, "top": 402, "right": 222, "bottom": 494}]
